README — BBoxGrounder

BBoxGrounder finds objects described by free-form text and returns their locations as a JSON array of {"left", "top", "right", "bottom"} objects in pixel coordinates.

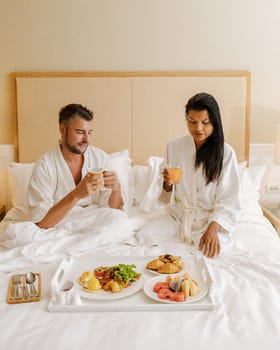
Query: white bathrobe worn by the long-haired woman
[{"left": 166, "top": 135, "right": 241, "bottom": 244}]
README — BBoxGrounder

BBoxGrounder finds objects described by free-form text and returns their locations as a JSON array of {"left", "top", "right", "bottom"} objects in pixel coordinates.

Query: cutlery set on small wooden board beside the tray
[{"left": 7, "top": 272, "right": 41, "bottom": 304}]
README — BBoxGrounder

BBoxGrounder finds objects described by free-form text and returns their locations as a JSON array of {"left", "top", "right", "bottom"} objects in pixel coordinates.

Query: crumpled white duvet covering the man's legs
[{"left": 0, "top": 206, "right": 135, "bottom": 271}]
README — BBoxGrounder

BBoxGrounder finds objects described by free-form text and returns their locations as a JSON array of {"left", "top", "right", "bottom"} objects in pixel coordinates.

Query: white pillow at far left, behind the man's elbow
[{"left": 7, "top": 162, "right": 35, "bottom": 216}]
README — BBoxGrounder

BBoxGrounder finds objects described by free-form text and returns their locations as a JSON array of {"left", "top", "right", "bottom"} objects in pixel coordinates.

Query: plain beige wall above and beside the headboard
[{"left": 0, "top": 0, "right": 280, "bottom": 143}]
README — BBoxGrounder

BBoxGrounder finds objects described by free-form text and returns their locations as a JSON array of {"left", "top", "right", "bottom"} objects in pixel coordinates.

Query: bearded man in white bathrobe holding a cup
[{"left": 27, "top": 104, "right": 123, "bottom": 228}]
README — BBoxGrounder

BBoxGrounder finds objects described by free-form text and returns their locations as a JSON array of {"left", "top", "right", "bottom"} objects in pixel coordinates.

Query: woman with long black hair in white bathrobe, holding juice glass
[{"left": 163, "top": 93, "right": 241, "bottom": 258}]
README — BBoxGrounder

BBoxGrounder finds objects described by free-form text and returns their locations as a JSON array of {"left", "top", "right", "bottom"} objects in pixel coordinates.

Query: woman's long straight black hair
[{"left": 186, "top": 92, "right": 224, "bottom": 184}]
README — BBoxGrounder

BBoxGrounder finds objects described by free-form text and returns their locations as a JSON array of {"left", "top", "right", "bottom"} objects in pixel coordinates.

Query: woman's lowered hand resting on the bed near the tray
[{"left": 198, "top": 221, "right": 221, "bottom": 258}]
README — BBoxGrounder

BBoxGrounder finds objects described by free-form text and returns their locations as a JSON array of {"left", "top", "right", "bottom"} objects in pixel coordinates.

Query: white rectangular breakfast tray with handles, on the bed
[{"left": 48, "top": 255, "right": 215, "bottom": 312}]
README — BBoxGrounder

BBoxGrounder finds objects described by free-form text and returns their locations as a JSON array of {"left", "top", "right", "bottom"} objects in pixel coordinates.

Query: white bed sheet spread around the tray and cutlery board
[{"left": 0, "top": 205, "right": 280, "bottom": 350}]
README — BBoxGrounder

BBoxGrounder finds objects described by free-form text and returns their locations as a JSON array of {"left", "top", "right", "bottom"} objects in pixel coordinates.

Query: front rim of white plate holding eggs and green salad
[{"left": 79, "top": 277, "right": 143, "bottom": 300}]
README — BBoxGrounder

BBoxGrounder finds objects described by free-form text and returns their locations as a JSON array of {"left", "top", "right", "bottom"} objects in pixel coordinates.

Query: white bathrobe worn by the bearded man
[{"left": 27, "top": 145, "right": 111, "bottom": 222}]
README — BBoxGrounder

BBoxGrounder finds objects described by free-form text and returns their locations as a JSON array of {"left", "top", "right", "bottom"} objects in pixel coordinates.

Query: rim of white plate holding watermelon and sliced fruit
[{"left": 144, "top": 276, "right": 208, "bottom": 304}]
